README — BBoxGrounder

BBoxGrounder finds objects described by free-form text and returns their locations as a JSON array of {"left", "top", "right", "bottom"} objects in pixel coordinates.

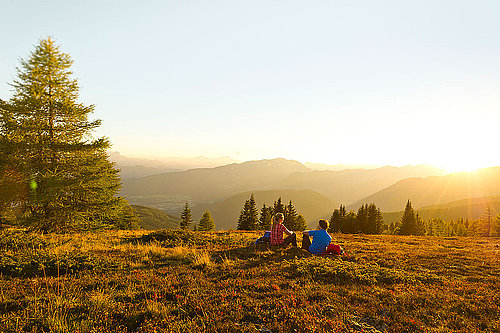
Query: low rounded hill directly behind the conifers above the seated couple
[{"left": 192, "top": 190, "right": 336, "bottom": 229}]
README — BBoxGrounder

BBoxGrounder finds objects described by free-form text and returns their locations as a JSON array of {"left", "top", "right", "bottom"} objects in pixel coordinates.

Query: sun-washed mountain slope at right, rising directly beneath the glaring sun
[{"left": 348, "top": 167, "right": 500, "bottom": 212}]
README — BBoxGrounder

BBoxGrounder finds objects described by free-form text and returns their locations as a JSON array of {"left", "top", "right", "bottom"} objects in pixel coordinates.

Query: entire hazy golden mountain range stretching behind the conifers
[{"left": 122, "top": 158, "right": 500, "bottom": 229}]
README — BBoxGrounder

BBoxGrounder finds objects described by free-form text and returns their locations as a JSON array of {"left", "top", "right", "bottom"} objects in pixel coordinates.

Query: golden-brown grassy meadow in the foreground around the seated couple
[{"left": 0, "top": 229, "right": 500, "bottom": 333}]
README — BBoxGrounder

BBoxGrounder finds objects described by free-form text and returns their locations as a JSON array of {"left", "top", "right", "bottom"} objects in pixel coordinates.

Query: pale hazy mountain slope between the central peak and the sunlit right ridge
[{"left": 276, "top": 165, "right": 442, "bottom": 204}]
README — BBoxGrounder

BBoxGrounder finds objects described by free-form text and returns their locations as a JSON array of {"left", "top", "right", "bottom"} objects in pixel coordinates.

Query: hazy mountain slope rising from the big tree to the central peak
[{"left": 122, "top": 159, "right": 309, "bottom": 201}]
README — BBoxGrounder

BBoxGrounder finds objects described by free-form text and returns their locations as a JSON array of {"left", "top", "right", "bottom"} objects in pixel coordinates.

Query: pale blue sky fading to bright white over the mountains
[{"left": 0, "top": 0, "right": 500, "bottom": 171}]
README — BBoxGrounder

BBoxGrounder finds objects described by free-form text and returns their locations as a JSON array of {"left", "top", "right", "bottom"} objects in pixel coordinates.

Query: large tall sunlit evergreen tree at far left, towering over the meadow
[{"left": 0, "top": 38, "right": 137, "bottom": 231}]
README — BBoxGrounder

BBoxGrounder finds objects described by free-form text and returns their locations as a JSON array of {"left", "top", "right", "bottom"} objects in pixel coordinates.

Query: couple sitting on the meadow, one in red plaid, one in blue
[{"left": 270, "top": 213, "right": 332, "bottom": 254}]
